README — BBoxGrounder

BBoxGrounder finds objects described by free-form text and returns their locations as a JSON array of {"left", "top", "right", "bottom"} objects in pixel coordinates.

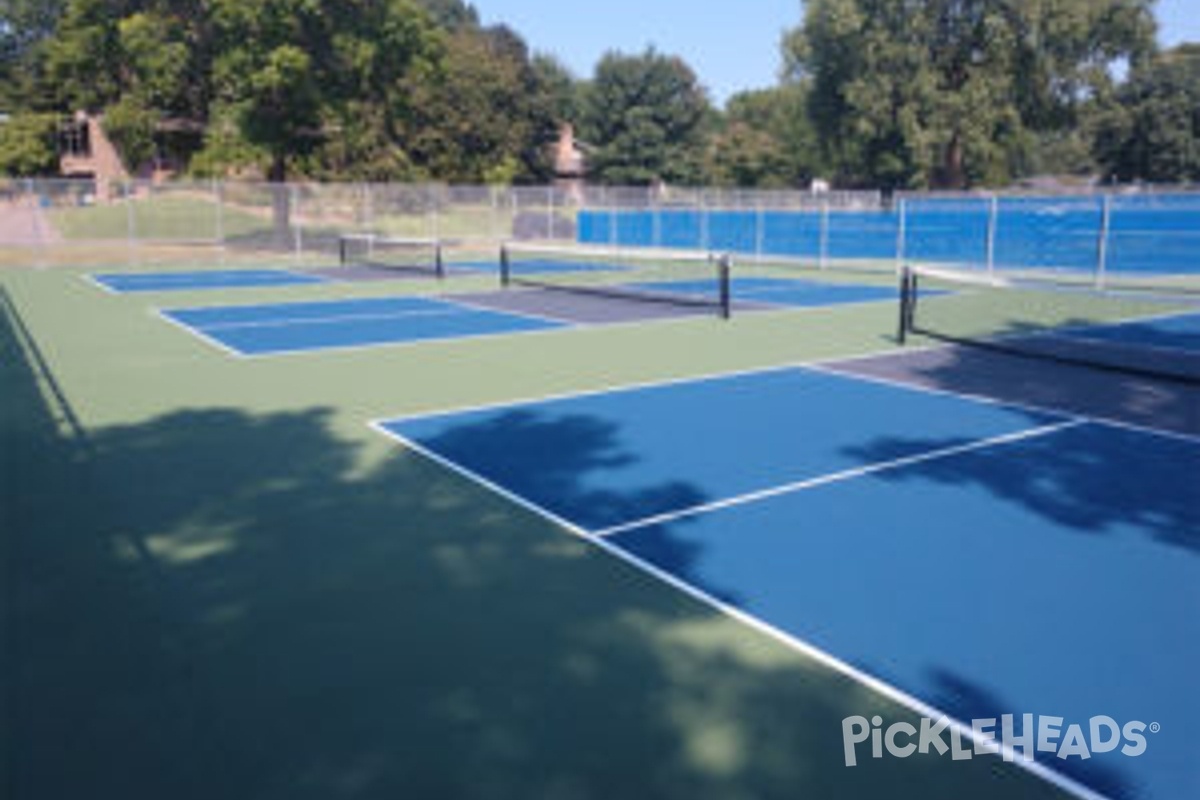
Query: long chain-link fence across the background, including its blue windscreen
[{"left": 0, "top": 179, "right": 1200, "bottom": 283}]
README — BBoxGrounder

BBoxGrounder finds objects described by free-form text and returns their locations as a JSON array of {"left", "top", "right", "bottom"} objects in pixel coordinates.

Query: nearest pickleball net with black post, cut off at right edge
[{"left": 899, "top": 267, "right": 1200, "bottom": 383}]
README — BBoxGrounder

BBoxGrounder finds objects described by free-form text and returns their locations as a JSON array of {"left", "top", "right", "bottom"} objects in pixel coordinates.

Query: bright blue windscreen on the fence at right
[{"left": 578, "top": 194, "right": 1200, "bottom": 275}]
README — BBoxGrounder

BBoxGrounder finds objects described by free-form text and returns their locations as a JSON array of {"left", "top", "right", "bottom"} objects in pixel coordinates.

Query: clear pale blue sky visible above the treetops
[{"left": 470, "top": 0, "right": 1200, "bottom": 103}]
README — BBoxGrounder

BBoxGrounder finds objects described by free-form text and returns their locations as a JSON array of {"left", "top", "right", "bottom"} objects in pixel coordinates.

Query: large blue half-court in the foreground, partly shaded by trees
[{"left": 378, "top": 368, "right": 1200, "bottom": 799}]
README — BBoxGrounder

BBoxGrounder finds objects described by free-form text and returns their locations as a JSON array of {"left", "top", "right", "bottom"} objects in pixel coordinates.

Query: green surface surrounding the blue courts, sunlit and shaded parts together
[{"left": 0, "top": 263, "right": 1062, "bottom": 800}]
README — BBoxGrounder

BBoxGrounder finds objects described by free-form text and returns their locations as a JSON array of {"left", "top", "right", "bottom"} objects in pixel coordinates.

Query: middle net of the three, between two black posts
[{"left": 500, "top": 243, "right": 732, "bottom": 318}]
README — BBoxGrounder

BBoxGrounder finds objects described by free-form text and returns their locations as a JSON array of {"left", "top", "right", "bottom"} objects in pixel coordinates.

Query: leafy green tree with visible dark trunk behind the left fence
[{"left": 200, "top": 0, "right": 442, "bottom": 235}]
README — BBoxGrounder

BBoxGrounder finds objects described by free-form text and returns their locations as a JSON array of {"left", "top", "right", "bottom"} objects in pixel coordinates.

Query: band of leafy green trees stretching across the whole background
[{"left": 0, "top": 0, "right": 1200, "bottom": 190}]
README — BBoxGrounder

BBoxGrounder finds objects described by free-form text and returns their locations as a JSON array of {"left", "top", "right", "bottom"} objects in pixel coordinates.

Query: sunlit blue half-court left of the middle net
[{"left": 161, "top": 297, "right": 564, "bottom": 355}]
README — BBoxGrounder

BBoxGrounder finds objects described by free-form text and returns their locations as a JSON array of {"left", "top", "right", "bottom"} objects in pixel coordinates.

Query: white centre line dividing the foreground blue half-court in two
[{"left": 592, "top": 419, "right": 1088, "bottom": 537}]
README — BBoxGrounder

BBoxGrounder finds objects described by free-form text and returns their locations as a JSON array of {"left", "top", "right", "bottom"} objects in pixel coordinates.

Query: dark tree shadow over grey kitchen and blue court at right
[{"left": 851, "top": 348, "right": 1200, "bottom": 553}]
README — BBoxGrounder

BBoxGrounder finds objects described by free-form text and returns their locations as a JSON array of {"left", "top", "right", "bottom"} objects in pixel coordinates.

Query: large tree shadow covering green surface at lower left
[{"left": 0, "top": 293, "right": 1070, "bottom": 800}]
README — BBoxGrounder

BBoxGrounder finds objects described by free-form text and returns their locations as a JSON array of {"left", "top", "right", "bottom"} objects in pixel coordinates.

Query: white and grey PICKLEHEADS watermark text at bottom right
[{"left": 841, "top": 714, "right": 1159, "bottom": 766}]
